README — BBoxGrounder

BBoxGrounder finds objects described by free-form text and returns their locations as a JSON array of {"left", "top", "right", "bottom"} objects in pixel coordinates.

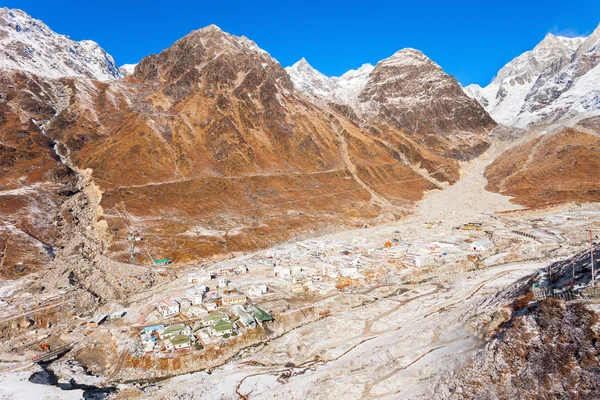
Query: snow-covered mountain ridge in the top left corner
[{"left": 0, "top": 7, "right": 125, "bottom": 81}]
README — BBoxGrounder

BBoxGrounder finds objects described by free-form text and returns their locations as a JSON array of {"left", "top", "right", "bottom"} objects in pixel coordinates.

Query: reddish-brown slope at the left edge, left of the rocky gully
[{"left": 0, "top": 71, "right": 74, "bottom": 277}]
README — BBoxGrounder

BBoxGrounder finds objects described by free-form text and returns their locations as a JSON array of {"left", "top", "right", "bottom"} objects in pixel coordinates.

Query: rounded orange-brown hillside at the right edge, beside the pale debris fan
[{"left": 485, "top": 120, "right": 600, "bottom": 207}]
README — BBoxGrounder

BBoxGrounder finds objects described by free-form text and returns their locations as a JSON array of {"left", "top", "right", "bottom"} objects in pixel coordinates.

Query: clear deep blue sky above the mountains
[{"left": 3, "top": 0, "right": 600, "bottom": 85}]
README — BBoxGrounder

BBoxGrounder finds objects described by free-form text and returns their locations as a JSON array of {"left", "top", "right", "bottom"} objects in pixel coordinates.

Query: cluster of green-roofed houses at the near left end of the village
[{"left": 140, "top": 305, "right": 273, "bottom": 352}]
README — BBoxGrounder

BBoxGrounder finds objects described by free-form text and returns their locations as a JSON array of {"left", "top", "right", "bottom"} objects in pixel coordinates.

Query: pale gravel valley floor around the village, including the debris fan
[{"left": 0, "top": 137, "right": 600, "bottom": 400}]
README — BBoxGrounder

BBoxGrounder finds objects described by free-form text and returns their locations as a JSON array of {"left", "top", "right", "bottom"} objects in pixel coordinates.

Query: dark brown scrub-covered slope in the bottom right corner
[{"left": 438, "top": 298, "right": 600, "bottom": 400}]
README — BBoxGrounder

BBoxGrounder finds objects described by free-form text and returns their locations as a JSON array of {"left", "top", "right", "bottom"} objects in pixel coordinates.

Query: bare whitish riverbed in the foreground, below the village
[{"left": 141, "top": 263, "right": 543, "bottom": 399}]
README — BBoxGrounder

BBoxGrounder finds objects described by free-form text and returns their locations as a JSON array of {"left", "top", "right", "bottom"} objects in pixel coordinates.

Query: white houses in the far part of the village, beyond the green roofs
[{"left": 262, "top": 233, "right": 494, "bottom": 295}]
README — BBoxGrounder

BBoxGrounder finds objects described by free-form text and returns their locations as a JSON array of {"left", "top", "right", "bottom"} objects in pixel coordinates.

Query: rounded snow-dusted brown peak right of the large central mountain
[{"left": 357, "top": 49, "right": 496, "bottom": 159}]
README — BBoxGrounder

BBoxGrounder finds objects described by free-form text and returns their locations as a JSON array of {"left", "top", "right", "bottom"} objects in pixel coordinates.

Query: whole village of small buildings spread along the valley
[{"left": 110, "top": 222, "right": 495, "bottom": 353}]
